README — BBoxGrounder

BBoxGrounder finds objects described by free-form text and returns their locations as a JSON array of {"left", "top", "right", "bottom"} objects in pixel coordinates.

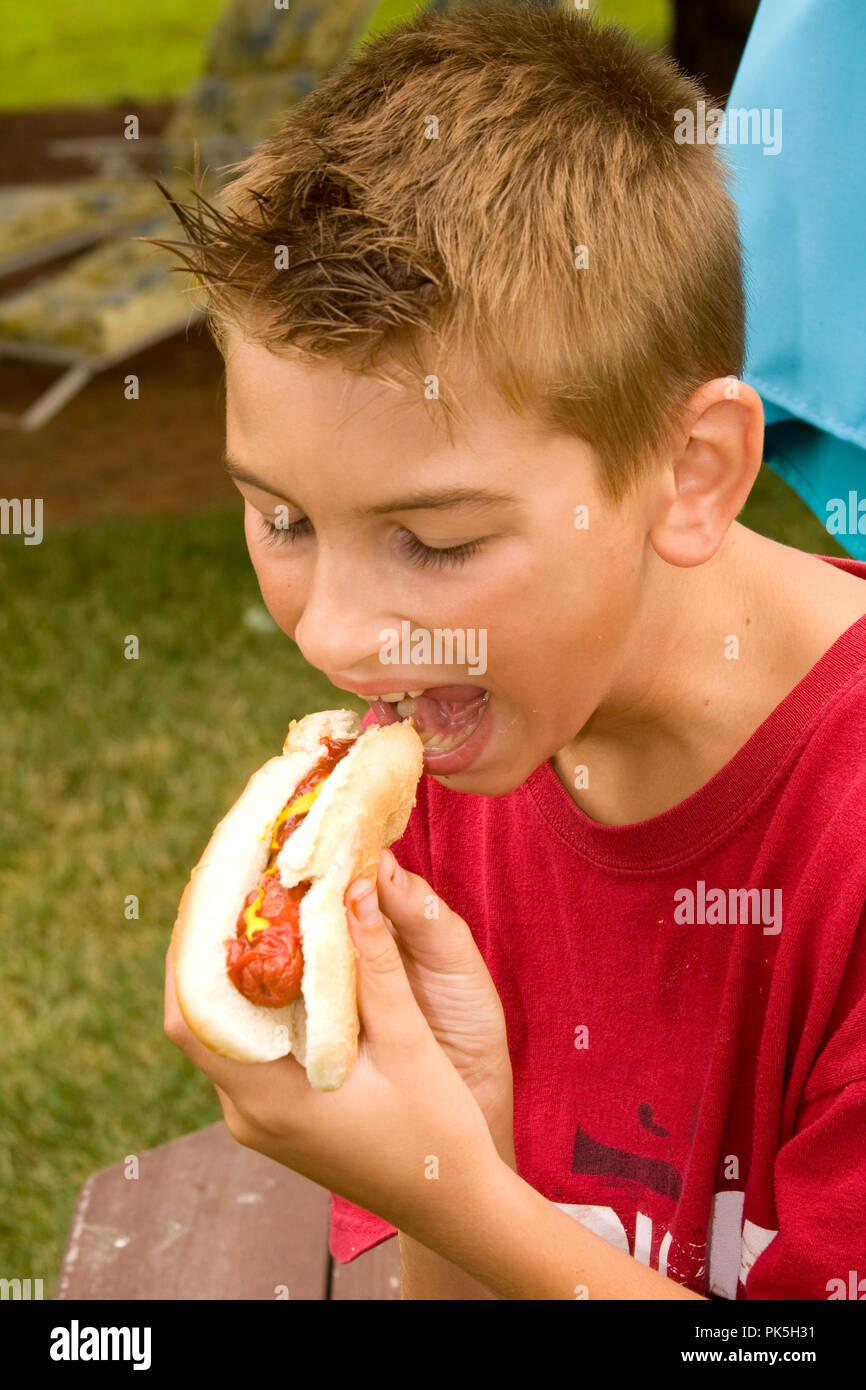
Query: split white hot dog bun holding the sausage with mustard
[{"left": 171, "top": 709, "right": 423, "bottom": 1091}]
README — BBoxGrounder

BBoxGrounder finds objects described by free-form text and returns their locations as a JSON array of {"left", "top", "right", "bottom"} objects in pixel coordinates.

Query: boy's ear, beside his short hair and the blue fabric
[{"left": 649, "top": 377, "right": 763, "bottom": 567}]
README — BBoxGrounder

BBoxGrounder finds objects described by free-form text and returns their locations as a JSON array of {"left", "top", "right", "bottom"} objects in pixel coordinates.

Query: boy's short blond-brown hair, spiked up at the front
[{"left": 161, "top": 3, "right": 745, "bottom": 499}]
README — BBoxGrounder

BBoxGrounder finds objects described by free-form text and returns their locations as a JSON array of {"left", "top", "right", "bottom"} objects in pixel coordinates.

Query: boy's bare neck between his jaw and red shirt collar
[{"left": 555, "top": 523, "right": 800, "bottom": 824}]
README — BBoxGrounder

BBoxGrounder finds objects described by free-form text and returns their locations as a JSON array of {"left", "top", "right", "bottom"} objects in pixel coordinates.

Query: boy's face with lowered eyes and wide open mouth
[{"left": 227, "top": 338, "right": 649, "bottom": 795}]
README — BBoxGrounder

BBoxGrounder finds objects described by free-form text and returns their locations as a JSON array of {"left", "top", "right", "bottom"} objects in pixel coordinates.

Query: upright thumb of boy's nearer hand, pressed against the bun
[{"left": 345, "top": 878, "right": 424, "bottom": 1044}]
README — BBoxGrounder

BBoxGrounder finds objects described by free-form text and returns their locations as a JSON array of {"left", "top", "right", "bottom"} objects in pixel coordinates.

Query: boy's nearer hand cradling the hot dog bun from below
[{"left": 165, "top": 878, "right": 513, "bottom": 1248}]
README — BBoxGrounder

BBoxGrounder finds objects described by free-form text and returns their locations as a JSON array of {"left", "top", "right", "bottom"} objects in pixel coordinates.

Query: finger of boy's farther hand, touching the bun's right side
[{"left": 377, "top": 849, "right": 487, "bottom": 973}]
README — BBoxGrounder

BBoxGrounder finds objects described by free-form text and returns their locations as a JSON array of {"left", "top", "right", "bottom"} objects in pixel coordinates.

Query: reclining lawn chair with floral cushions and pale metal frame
[{"left": 0, "top": 0, "right": 378, "bottom": 430}]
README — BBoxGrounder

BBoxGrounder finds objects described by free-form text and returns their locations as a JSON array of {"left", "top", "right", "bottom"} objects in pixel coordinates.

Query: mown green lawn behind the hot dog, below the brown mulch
[{"left": 0, "top": 468, "right": 845, "bottom": 1297}]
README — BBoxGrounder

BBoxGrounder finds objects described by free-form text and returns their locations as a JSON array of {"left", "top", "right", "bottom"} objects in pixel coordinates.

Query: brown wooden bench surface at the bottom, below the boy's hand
[{"left": 54, "top": 1120, "right": 400, "bottom": 1302}]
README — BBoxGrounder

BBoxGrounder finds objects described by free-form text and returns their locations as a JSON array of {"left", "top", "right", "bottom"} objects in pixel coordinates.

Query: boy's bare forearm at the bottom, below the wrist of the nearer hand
[{"left": 410, "top": 1155, "right": 703, "bottom": 1301}]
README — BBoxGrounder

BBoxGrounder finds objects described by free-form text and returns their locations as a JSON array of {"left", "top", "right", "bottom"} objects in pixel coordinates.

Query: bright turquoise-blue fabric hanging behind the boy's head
[{"left": 720, "top": 0, "right": 866, "bottom": 560}]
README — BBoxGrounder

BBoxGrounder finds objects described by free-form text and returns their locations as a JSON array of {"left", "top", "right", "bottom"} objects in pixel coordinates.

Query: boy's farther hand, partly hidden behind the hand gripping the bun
[{"left": 377, "top": 849, "right": 514, "bottom": 1156}]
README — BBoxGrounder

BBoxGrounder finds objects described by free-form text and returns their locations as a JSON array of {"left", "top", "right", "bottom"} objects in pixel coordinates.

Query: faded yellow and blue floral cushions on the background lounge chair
[{"left": 0, "top": 0, "right": 373, "bottom": 356}]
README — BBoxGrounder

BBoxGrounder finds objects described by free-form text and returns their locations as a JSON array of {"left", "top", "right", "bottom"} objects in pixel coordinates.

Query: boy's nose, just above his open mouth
[{"left": 292, "top": 545, "right": 399, "bottom": 671}]
